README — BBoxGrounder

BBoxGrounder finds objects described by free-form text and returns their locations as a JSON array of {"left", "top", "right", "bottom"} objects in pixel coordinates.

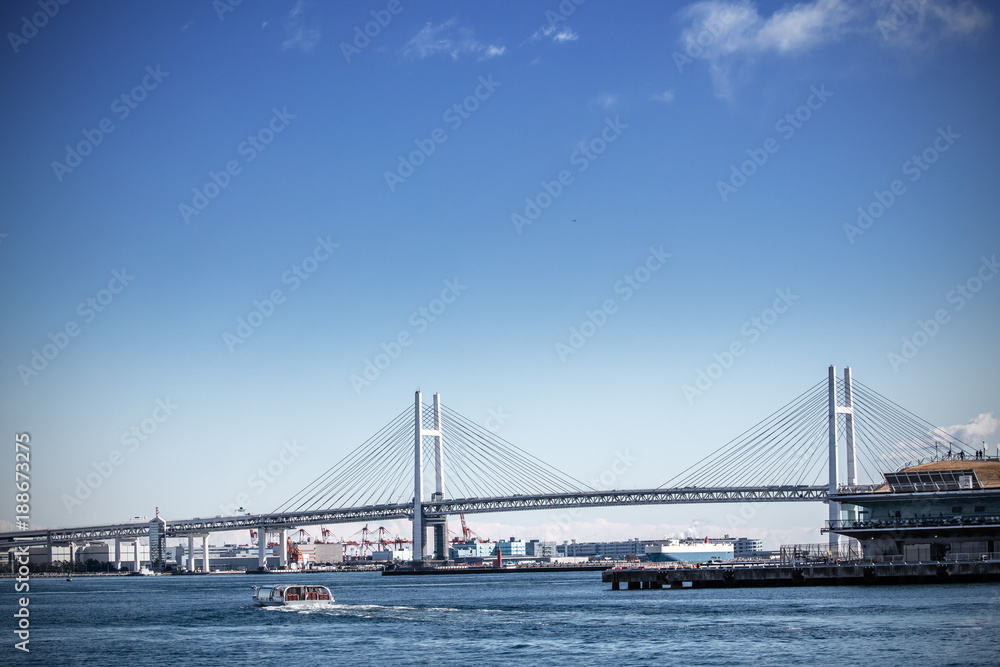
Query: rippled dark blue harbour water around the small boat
[{"left": 0, "top": 572, "right": 1000, "bottom": 665}]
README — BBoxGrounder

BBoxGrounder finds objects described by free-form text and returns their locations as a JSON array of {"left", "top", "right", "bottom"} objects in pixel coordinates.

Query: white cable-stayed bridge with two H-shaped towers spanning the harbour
[{"left": 0, "top": 366, "right": 974, "bottom": 569}]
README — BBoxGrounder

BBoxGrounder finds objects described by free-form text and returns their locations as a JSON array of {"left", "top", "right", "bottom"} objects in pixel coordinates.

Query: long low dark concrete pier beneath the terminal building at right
[{"left": 601, "top": 560, "right": 1000, "bottom": 591}]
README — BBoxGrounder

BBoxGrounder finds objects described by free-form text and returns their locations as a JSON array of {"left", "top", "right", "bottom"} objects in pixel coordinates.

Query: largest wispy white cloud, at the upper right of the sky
[{"left": 680, "top": 0, "right": 991, "bottom": 97}]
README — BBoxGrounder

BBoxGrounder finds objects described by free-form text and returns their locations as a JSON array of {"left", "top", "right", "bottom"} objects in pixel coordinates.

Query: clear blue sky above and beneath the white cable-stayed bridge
[{"left": 0, "top": 0, "right": 1000, "bottom": 547}]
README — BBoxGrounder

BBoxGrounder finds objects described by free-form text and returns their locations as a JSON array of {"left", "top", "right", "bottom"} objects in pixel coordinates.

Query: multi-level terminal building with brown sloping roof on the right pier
[{"left": 823, "top": 459, "right": 1000, "bottom": 562}]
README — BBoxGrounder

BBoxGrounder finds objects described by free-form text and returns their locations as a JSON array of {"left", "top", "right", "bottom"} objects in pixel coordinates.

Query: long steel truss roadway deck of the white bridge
[{"left": 0, "top": 486, "right": 828, "bottom": 549}]
